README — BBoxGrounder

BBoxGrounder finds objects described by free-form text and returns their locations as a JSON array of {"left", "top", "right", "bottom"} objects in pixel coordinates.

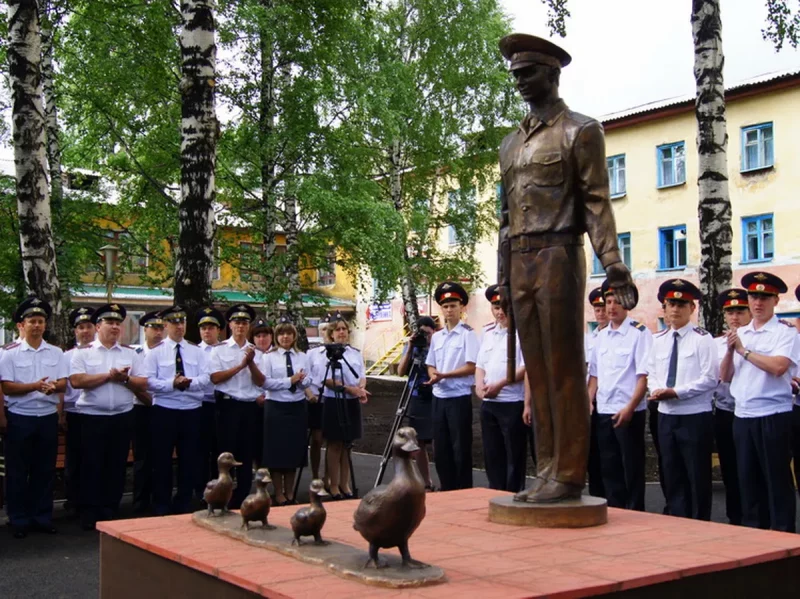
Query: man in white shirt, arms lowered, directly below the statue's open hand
[{"left": 589, "top": 280, "right": 653, "bottom": 511}]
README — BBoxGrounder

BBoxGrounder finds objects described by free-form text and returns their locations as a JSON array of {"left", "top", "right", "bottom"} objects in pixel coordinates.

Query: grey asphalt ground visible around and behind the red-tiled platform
[{"left": 0, "top": 454, "right": 800, "bottom": 599}]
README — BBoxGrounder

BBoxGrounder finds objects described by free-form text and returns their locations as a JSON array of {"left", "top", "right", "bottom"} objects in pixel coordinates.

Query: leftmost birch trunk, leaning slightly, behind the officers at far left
[{"left": 8, "top": 0, "right": 63, "bottom": 343}]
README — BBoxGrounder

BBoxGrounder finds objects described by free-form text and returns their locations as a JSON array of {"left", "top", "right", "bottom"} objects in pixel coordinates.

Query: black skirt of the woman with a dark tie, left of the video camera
[{"left": 261, "top": 399, "right": 308, "bottom": 470}]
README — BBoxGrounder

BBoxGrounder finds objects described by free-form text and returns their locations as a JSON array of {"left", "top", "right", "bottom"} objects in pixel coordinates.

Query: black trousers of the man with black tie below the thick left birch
[{"left": 152, "top": 406, "right": 202, "bottom": 516}]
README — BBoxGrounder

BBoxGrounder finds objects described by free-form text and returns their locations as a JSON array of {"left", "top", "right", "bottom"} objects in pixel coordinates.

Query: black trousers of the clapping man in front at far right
[{"left": 733, "top": 412, "right": 797, "bottom": 532}]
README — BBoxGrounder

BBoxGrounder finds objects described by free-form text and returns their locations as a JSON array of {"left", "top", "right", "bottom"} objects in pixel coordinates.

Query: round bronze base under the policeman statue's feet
[{"left": 489, "top": 495, "right": 608, "bottom": 528}]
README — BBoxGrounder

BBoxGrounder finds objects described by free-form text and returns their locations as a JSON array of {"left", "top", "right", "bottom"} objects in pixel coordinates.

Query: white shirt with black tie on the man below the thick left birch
[{"left": 144, "top": 337, "right": 211, "bottom": 410}]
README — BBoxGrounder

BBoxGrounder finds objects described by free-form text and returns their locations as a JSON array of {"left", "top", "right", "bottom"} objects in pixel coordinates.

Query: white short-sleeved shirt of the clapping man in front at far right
[{"left": 731, "top": 316, "right": 800, "bottom": 418}]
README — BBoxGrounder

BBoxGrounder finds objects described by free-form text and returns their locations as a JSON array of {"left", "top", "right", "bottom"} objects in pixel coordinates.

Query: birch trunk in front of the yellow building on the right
[{"left": 691, "top": 0, "right": 732, "bottom": 335}]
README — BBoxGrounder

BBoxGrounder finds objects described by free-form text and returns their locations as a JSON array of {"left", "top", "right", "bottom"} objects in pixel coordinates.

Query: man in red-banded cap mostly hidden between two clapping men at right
[{"left": 714, "top": 288, "right": 751, "bottom": 526}]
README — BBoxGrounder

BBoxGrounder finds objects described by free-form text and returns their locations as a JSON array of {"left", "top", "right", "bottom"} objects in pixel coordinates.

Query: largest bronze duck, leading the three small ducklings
[{"left": 353, "top": 427, "right": 428, "bottom": 568}]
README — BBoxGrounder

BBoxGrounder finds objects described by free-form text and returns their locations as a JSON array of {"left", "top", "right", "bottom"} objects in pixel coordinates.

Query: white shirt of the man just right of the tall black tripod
[{"left": 425, "top": 322, "right": 480, "bottom": 398}]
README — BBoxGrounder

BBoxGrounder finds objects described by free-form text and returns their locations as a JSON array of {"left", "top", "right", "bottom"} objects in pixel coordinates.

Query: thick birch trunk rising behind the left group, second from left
[{"left": 175, "top": 0, "right": 219, "bottom": 340}]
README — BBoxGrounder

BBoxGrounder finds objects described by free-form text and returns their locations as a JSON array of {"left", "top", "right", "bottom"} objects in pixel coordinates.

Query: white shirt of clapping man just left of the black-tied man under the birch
[{"left": 70, "top": 339, "right": 145, "bottom": 416}]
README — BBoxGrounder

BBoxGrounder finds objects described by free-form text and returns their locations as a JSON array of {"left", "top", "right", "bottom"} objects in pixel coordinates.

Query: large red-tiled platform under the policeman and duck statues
[{"left": 98, "top": 489, "right": 800, "bottom": 599}]
